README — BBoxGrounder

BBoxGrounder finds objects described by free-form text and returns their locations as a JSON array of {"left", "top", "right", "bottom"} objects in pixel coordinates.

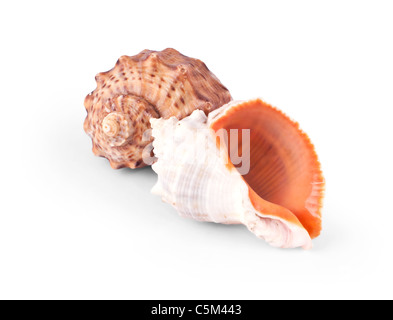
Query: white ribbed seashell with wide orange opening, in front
[{"left": 150, "top": 99, "right": 324, "bottom": 249}]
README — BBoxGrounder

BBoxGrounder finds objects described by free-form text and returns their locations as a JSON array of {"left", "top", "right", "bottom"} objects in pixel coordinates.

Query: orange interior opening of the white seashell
[{"left": 212, "top": 100, "right": 324, "bottom": 238}]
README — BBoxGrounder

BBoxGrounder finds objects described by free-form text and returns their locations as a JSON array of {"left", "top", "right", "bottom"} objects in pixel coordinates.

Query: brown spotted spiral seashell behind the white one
[{"left": 84, "top": 49, "right": 232, "bottom": 169}]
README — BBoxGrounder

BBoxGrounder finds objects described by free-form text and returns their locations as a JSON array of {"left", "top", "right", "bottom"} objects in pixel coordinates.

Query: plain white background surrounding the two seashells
[{"left": 0, "top": 0, "right": 393, "bottom": 299}]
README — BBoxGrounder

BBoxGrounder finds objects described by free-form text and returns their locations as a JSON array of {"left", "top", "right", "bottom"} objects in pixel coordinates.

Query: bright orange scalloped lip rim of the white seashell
[{"left": 209, "top": 98, "right": 325, "bottom": 238}]
